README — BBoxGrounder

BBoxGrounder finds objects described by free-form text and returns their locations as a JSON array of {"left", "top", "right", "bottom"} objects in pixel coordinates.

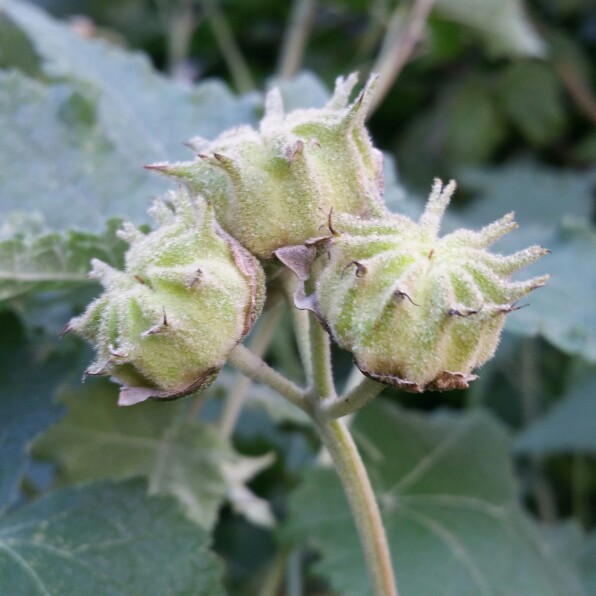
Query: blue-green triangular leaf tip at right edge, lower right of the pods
[{"left": 515, "top": 371, "right": 596, "bottom": 455}]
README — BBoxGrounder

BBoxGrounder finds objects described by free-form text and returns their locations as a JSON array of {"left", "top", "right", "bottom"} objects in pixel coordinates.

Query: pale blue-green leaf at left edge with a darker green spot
[{"left": 0, "top": 72, "right": 165, "bottom": 233}]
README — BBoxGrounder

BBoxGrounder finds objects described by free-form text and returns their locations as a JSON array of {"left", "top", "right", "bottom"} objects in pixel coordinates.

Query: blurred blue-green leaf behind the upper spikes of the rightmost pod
[{"left": 458, "top": 160, "right": 596, "bottom": 229}]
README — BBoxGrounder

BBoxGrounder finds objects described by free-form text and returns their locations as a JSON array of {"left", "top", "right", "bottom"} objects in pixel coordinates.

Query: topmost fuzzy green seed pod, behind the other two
[{"left": 148, "top": 75, "right": 384, "bottom": 259}]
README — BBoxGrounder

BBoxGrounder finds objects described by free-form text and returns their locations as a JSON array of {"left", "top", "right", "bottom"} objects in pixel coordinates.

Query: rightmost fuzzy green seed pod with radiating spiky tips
[{"left": 311, "top": 180, "right": 548, "bottom": 392}]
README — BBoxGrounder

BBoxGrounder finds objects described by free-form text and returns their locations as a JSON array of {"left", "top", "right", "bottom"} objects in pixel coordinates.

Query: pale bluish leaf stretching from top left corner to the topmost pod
[{"left": 0, "top": 0, "right": 258, "bottom": 163}]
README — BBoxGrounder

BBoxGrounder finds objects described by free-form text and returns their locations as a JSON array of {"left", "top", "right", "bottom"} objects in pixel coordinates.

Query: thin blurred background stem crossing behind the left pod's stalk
[{"left": 218, "top": 304, "right": 282, "bottom": 437}]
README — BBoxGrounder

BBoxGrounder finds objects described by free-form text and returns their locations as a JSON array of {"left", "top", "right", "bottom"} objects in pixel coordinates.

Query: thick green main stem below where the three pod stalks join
[{"left": 315, "top": 420, "right": 397, "bottom": 596}]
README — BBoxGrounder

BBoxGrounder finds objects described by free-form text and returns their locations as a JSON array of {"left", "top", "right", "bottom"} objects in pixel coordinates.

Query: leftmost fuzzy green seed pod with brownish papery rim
[{"left": 66, "top": 192, "right": 264, "bottom": 405}]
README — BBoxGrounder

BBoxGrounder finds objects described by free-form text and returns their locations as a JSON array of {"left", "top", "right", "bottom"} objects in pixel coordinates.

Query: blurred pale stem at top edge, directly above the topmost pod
[{"left": 277, "top": 0, "right": 316, "bottom": 79}]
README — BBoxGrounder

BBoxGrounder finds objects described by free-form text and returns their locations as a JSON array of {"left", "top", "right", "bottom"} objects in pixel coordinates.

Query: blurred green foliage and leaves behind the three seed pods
[{"left": 0, "top": 0, "right": 596, "bottom": 596}]
